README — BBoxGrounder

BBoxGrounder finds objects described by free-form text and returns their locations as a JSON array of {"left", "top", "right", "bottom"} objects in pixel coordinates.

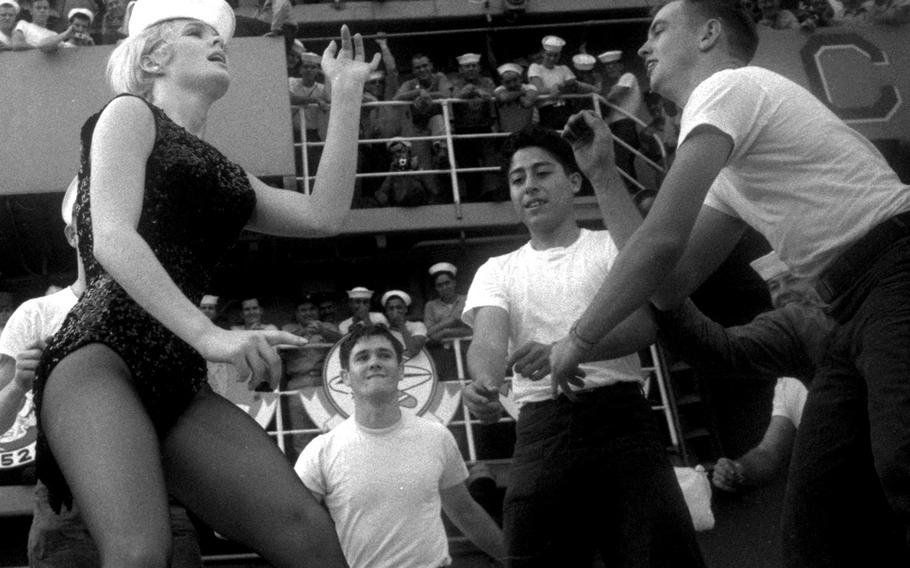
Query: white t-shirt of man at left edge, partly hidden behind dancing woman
[{"left": 0, "top": 286, "right": 78, "bottom": 359}]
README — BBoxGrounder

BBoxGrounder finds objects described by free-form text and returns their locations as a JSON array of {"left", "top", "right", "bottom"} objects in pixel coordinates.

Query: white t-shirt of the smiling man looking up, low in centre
[{"left": 294, "top": 413, "right": 468, "bottom": 568}]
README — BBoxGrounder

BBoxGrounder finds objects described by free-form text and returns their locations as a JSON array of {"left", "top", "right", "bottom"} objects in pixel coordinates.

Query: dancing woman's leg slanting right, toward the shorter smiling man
[{"left": 163, "top": 389, "right": 347, "bottom": 568}]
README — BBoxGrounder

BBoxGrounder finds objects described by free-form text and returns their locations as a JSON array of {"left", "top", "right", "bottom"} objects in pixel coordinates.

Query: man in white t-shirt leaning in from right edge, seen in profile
[{"left": 551, "top": 0, "right": 910, "bottom": 567}]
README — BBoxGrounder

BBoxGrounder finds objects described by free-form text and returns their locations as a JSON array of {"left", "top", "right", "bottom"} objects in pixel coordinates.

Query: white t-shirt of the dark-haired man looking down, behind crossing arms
[{"left": 462, "top": 229, "right": 642, "bottom": 407}]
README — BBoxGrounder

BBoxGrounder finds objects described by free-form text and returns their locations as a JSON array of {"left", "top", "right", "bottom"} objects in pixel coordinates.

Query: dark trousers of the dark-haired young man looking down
[{"left": 503, "top": 383, "right": 704, "bottom": 568}]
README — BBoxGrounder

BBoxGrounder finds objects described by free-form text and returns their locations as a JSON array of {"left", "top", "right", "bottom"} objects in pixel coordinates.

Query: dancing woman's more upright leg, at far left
[{"left": 41, "top": 344, "right": 171, "bottom": 568}]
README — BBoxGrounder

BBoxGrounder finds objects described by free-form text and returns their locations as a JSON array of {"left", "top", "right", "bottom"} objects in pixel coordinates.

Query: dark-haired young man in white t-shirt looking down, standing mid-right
[{"left": 462, "top": 126, "right": 704, "bottom": 567}]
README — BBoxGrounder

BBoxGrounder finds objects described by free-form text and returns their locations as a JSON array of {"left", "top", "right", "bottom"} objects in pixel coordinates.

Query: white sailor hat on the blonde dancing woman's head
[{"left": 126, "top": 0, "right": 235, "bottom": 43}]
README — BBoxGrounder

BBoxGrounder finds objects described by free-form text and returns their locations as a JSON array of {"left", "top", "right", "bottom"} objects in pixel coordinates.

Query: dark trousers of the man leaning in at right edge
[{"left": 783, "top": 219, "right": 910, "bottom": 568}]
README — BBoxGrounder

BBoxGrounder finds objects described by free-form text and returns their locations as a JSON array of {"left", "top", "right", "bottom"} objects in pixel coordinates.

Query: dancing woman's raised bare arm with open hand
[{"left": 248, "top": 26, "right": 380, "bottom": 237}]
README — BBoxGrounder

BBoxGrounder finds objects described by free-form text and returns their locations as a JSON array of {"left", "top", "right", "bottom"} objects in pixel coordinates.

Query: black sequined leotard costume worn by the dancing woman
[{"left": 35, "top": 95, "right": 256, "bottom": 511}]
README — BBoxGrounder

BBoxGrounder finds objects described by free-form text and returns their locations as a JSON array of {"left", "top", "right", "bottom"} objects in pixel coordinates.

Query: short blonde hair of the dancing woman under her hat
[{"left": 107, "top": 19, "right": 188, "bottom": 100}]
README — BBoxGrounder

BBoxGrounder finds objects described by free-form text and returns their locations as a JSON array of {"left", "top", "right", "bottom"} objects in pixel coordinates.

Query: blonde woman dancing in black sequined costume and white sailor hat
[{"left": 35, "top": 0, "right": 378, "bottom": 567}]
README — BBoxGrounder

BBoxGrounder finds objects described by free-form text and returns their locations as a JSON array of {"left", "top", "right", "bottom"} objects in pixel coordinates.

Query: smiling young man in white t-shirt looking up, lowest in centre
[{"left": 294, "top": 324, "right": 504, "bottom": 568}]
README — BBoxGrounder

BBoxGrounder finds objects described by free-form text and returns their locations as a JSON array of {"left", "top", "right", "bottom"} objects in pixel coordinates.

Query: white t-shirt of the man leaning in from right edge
[{"left": 679, "top": 67, "right": 910, "bottom": 279}]
